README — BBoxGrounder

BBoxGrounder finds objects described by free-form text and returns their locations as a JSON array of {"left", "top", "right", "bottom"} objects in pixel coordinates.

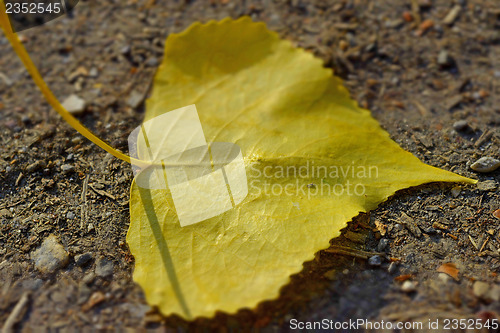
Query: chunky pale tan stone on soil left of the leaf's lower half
[{"left": 31, "top": 235, "right": 69, "bottom": 273}]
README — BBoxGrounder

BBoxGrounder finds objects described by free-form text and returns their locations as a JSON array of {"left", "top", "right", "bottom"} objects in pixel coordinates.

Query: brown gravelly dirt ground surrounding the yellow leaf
[{"left": 0, "top": 0, "right": 500, "bottom": 332}]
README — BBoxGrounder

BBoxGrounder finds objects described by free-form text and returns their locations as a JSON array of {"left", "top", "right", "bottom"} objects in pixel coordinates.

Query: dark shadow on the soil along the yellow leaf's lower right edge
[{"left": 143, "top": 210, "right": 392, "bottom": 332}]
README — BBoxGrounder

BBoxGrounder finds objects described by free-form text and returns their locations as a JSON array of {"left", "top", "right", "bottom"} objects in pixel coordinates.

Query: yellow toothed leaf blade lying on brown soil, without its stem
[{"left": 127, "top": 18, "right": 473, "bottom": 319}]
